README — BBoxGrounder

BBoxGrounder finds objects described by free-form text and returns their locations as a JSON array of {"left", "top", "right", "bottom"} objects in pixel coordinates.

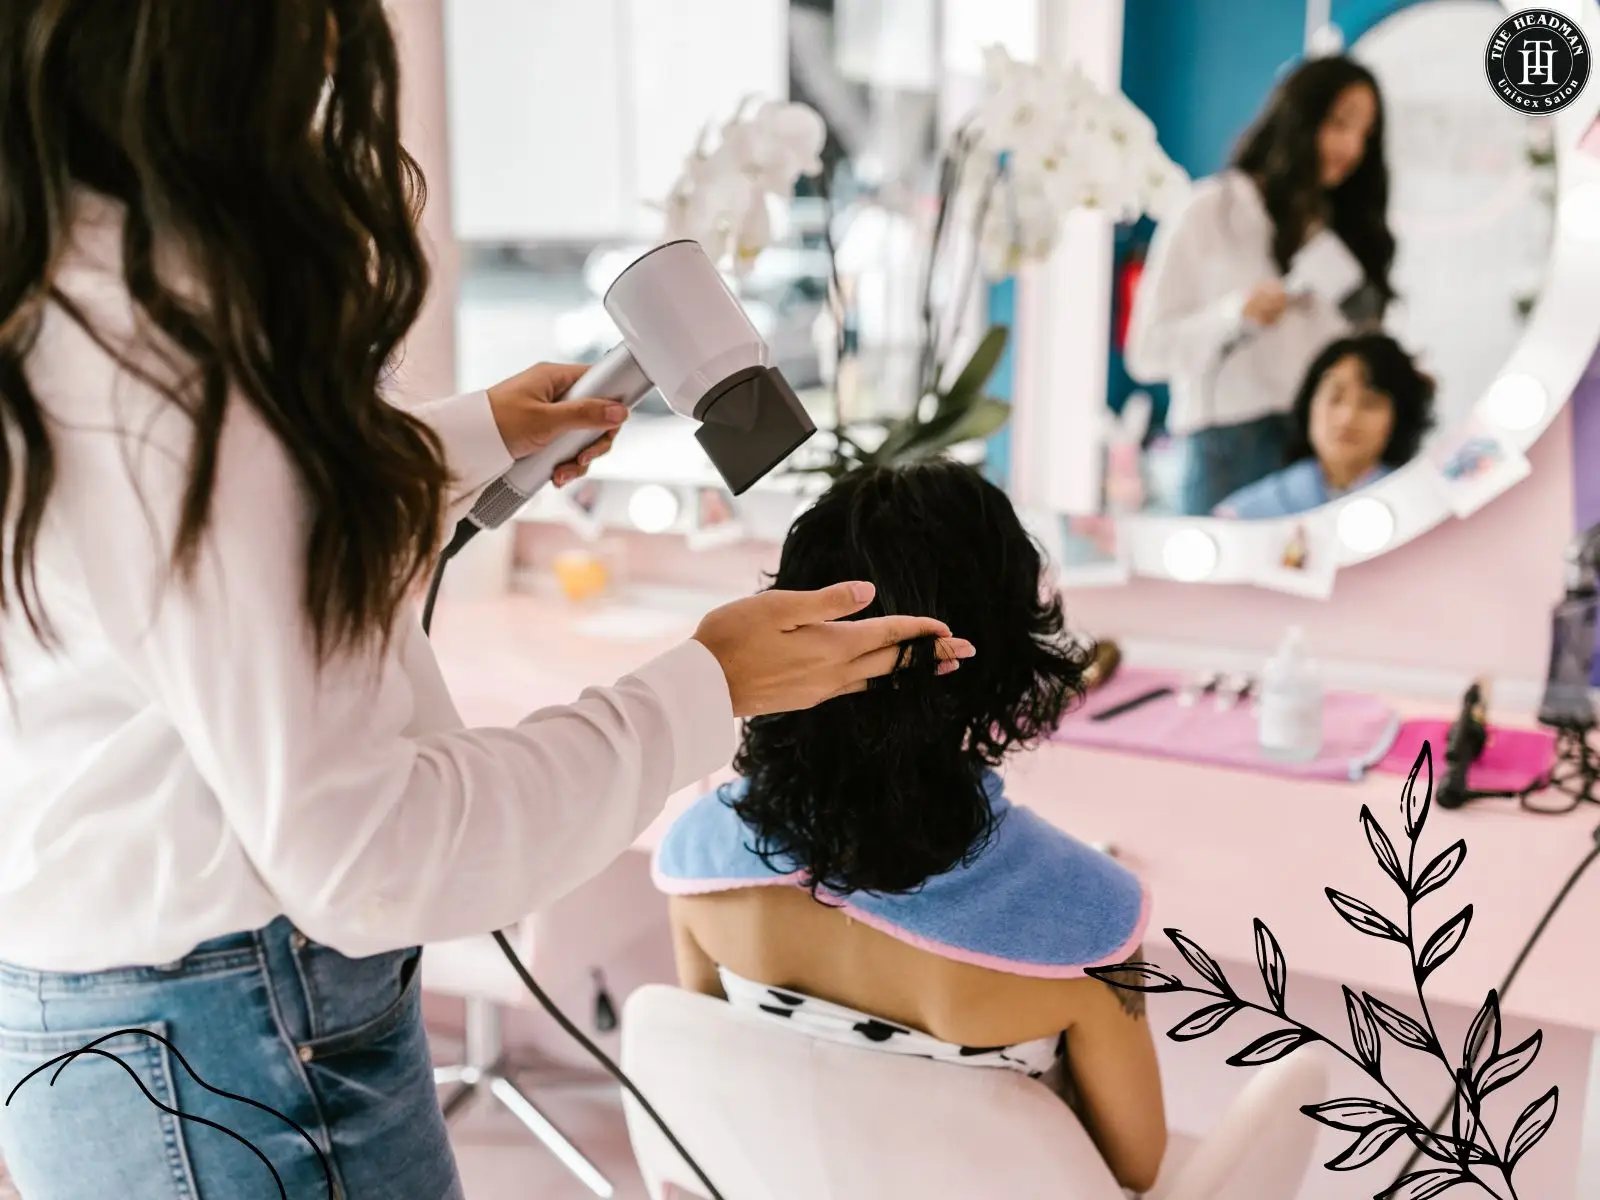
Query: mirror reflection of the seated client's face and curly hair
[{"left": 1214, "top": 333, "right": 1434, "bottom": 520}]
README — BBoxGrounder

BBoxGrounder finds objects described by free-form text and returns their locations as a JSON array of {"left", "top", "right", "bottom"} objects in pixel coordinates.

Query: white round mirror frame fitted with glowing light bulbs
[{"left": 1043, "top": 0, "right": 1600, "bottom": 594}]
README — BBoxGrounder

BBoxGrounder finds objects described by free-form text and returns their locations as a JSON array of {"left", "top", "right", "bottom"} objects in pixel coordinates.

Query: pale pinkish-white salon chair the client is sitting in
[{"left": 622, "top": 986, "right": 1328, "bottom": 1200}]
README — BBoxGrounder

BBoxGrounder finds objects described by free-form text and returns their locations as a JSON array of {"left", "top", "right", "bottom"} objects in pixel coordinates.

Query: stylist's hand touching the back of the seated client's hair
[{"left": 694, "top": 584, "right": 976, "bottom": 717}]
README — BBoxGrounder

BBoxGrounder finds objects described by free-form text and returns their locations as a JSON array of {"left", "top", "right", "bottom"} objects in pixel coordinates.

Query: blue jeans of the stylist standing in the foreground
[{"left": 0, "top": 918, "right": 462, "bottom": 1200}]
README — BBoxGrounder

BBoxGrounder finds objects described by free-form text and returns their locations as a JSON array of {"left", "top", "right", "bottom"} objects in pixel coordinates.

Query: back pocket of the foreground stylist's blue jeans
[{"left": 0, "top": 1021, "right": 198, "bottom": 1200}]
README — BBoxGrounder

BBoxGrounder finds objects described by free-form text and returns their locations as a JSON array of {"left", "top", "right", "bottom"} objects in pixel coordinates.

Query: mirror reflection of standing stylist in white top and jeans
[{"left": 1126, "top": 58, "right": 1394, "bottom": 515}]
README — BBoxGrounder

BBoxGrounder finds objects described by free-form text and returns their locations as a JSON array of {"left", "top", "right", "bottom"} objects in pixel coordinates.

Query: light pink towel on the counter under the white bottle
[{"left": 1054, "top": 667, "right": 1395, "bottom": 781}]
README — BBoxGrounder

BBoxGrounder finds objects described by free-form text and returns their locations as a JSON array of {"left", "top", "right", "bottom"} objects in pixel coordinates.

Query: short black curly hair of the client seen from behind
[{"left": 723, "top": 462, "right": 1093, "bottom": 896}]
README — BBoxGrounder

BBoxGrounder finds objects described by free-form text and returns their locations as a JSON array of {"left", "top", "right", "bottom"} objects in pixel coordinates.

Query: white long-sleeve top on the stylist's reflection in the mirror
[{"left": 1123, "top": 170, "right": 1350, "bottom": 434}]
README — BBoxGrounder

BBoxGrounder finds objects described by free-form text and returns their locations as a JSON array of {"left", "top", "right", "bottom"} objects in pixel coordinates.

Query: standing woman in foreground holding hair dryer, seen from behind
[{"left": 0, "top": 0, "right": 971, "bottom": 1200}]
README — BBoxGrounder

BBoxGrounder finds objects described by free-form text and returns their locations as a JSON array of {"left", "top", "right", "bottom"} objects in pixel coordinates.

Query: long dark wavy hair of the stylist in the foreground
[{"left": 0, "top": 0, "right": 450, "bottom": 668}]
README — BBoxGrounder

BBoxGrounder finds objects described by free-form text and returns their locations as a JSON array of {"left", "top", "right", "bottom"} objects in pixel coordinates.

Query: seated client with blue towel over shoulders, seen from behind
[{"left": 654, "top": 462, "right": 1166, "bottom": 1190}]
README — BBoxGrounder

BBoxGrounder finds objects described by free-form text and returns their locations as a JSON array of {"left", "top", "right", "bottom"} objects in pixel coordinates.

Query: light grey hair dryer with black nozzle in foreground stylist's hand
[{"left": 467, "top": 238, "right": 816, "bottom": 536}]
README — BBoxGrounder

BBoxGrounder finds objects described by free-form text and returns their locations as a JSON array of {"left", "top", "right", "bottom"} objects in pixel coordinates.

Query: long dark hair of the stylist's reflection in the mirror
[{"left": 1234, "top": 54, "right": 1395, "bottom": 306}]
